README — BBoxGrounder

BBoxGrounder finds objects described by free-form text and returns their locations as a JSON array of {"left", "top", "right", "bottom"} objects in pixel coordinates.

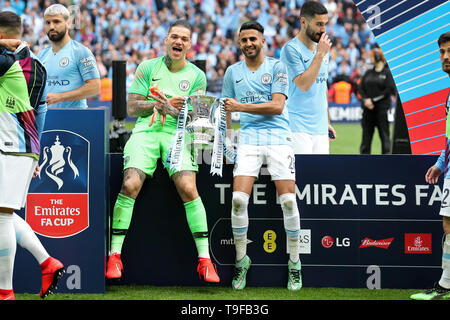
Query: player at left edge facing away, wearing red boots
[{"left": 0, "top": 11, "right": 64, "bottom": 300}]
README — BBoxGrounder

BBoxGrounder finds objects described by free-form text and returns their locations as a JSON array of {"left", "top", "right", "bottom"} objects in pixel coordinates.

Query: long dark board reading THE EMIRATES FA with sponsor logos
[{"left": 110, "top": 153, "right": 443, "bottom": 289}]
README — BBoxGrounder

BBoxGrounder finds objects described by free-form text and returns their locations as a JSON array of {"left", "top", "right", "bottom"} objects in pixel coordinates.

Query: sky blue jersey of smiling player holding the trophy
[{"left": 222, "top": 57, "right": 292, "bottom": 145}]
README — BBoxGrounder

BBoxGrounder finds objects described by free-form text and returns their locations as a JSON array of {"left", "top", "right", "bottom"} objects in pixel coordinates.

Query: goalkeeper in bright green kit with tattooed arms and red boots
[{"left": 106, "top": 20, "right": 220, "bottom": 282}]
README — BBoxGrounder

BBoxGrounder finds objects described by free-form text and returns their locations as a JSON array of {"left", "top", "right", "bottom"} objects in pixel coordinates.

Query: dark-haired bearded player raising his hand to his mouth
[{"left": 280, "top": 1, "right": 336, "bottom": 154}]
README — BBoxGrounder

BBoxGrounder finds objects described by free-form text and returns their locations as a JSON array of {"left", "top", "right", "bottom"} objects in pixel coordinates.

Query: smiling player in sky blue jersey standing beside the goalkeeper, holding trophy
[{"left": 222, "top": 21, "right": 302, "bottom": 290}]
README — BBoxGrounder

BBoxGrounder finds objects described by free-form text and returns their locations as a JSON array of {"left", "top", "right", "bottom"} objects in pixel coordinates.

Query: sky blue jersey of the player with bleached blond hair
[{"left": 38, "top": 40, "right": 100, "bottom": 109}]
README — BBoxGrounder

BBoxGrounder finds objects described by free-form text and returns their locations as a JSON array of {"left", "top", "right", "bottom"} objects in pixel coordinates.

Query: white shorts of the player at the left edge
[{"left": 0, "top": 152, "right": 37, "bottom": 210}]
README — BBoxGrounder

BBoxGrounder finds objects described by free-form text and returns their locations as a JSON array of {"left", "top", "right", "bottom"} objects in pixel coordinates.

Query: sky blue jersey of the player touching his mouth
[{"left": 280, "top": 37, "right": 330, "bottom": 135}]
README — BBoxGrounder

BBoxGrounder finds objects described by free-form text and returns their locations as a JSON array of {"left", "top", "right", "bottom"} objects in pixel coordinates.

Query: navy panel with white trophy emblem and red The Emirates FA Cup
[{"left": 14, "top": 108, "right": 109, "bottom": 293}]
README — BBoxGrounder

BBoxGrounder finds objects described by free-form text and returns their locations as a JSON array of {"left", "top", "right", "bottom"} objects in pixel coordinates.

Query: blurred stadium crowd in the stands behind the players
[{"left": 0, "top": 0, "right": 376, "bottom": 103}]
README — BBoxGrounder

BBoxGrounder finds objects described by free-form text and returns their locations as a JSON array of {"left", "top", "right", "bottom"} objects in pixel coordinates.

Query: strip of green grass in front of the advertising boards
[{"left": 15, "top": 285, "right": 422, "bottom": 300}]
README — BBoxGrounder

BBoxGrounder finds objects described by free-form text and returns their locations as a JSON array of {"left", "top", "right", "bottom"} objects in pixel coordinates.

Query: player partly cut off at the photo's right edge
[{"left": 411, "top": 31, "right": 450, "bottom": 300}]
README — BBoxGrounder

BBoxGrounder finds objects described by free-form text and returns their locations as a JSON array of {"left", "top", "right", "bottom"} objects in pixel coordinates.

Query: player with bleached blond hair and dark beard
[{"left": 38, "top": 4, "right": 100, "bottom": 109}]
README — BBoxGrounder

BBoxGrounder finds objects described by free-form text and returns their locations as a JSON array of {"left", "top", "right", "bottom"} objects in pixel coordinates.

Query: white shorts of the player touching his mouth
[{"left": 292, "top": 132, "right": 330, "bottom": 154}]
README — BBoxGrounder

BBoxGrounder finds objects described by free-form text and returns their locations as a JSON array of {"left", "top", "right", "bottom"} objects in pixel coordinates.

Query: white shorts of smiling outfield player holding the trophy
[{"left": 233, "top": 144, "right": 295, "bottom": 180}]
